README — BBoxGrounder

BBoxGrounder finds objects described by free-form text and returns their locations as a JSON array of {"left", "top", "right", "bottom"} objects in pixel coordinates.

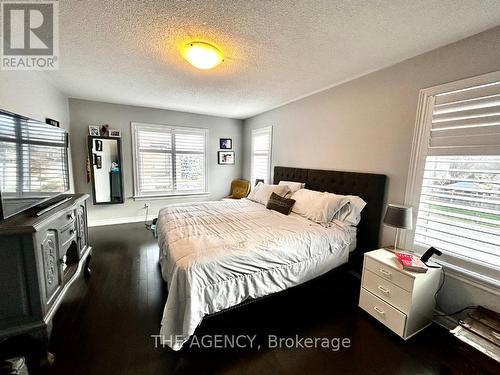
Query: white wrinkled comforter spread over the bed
[{"left": 158, "top": 200, "right": 355, "bottom": 350}]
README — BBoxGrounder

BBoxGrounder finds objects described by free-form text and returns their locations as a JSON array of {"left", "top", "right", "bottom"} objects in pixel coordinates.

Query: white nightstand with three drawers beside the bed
[{"left": 359, "top": 249, "right": 441, "bottom": 340}]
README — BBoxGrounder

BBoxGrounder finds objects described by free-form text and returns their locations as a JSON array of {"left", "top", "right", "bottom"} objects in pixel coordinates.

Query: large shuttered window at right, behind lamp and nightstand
[{"left": 409, "top": 73, "right": 500, "bottom": 283}]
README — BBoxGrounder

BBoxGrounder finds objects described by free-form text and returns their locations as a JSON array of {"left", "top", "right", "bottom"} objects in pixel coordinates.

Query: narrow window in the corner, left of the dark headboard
[{"left": 251, "top": 126, "right": 273, "bottom": 184}]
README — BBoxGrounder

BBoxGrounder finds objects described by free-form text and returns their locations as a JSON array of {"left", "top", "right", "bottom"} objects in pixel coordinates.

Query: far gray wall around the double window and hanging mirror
[{"left": 69, "top": 99, "right": 243, "bottom": 225}]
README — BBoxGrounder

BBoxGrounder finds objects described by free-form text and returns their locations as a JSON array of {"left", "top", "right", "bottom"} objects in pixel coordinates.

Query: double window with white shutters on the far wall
[{"left": 132, "top": 123, "right": 208, "bottom": 197}]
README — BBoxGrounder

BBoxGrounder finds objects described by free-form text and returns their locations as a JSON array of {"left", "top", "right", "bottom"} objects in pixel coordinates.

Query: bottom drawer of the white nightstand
[{"left": 359, "top": 288, "right": 406, "bottom": 336}]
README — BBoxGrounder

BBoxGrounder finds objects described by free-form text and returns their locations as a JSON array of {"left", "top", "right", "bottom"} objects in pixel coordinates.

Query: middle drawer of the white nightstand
[{"left": 363, "top": 270, "right": 411, "bottom": 313}]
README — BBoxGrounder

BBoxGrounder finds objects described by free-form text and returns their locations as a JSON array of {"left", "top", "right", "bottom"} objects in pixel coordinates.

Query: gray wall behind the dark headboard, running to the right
[{"left": 243, "top": 27, "right": 500, "bottom": 311}]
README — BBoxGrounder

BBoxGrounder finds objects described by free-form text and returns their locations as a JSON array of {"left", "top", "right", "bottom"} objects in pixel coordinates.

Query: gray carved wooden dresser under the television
[{"left": 0, "top": 194, "right": 91, "bottom": 341}]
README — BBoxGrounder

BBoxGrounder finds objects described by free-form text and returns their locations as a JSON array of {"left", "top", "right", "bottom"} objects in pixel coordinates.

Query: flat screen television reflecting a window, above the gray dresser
[{"left": 0, "top": 110, "right": 69, "bottom": 220}]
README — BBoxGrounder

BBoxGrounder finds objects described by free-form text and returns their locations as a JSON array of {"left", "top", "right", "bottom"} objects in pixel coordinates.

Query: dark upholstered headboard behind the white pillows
[{"left": 273, "top": 167, "right": 386, "bottom": 270}]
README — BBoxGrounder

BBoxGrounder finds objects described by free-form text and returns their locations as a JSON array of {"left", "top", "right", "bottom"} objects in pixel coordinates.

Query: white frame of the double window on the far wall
[{"left": 130, "top": 121, "right": 210, "bottom": 200}]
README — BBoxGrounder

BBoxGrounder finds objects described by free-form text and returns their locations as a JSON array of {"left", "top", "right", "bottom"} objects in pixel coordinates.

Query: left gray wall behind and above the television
[{"left": 0, "top": 71, "right": 74, "bottom": 191}]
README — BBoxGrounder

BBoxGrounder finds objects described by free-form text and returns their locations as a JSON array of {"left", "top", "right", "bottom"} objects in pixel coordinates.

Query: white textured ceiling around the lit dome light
[{"left": 49, "top": 0, "right": 500, "bottom": 118}]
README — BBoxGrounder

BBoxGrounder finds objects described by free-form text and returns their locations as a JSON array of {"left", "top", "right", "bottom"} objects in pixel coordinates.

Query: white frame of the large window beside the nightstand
[{"left": 402, "top": 71, "right": 500, "bottom": 287}]
